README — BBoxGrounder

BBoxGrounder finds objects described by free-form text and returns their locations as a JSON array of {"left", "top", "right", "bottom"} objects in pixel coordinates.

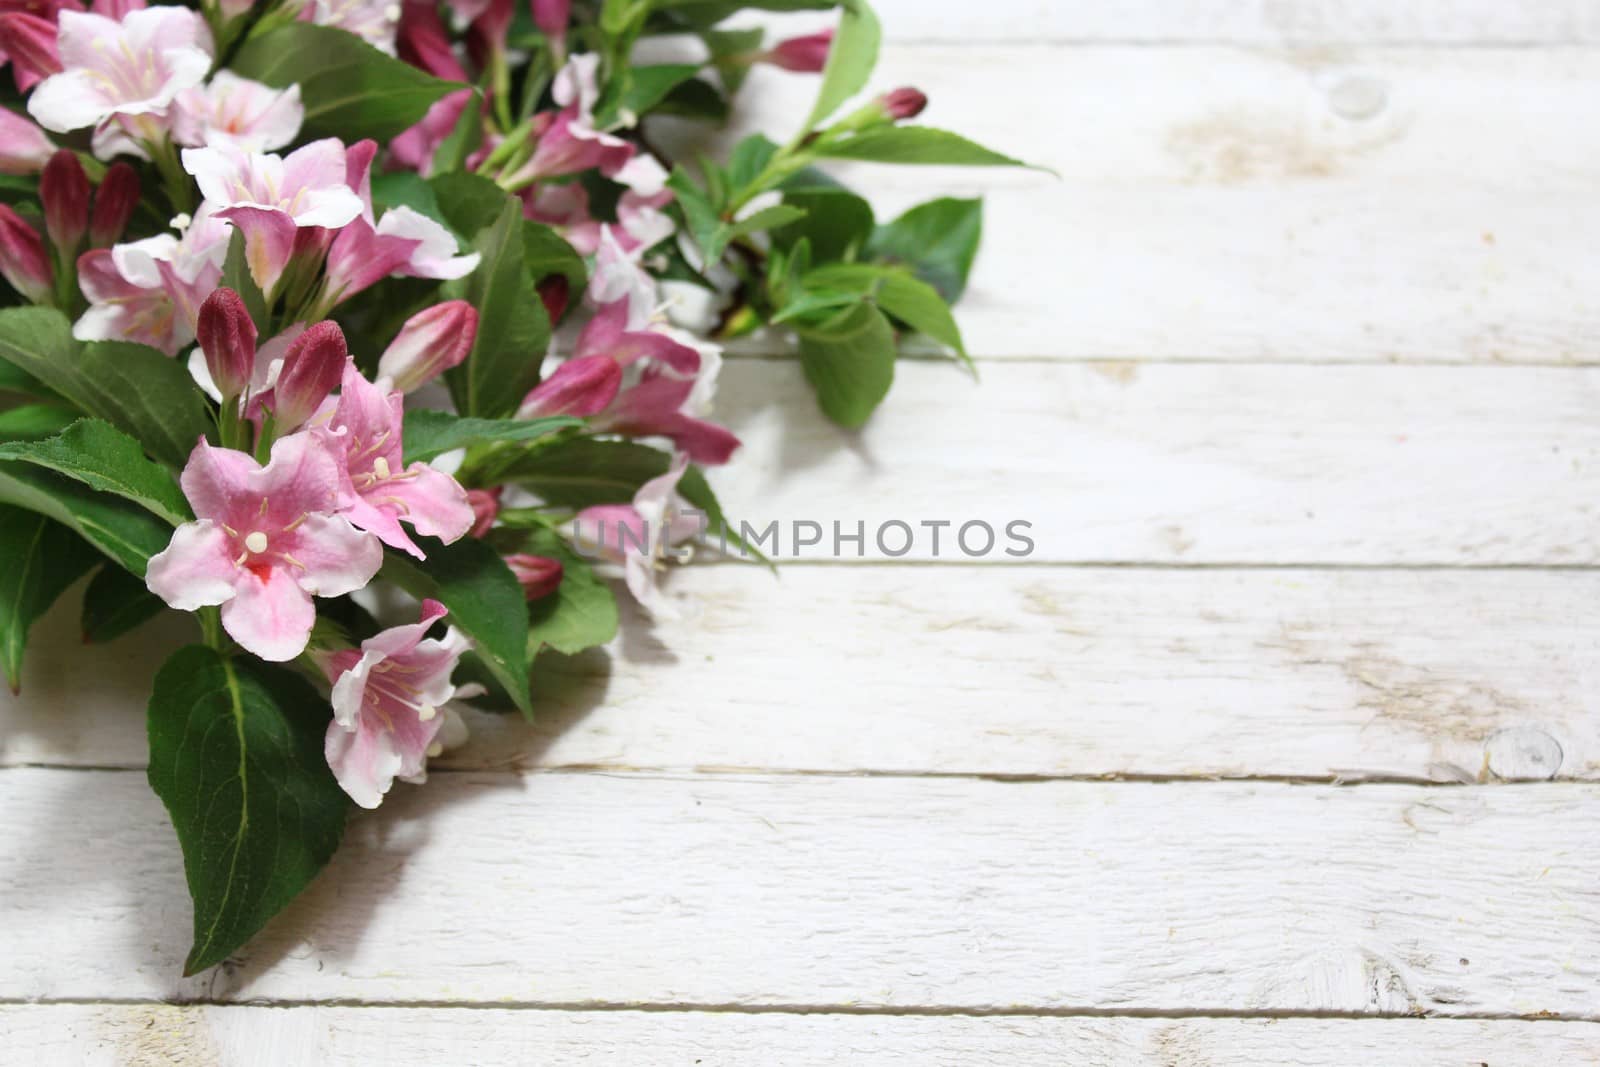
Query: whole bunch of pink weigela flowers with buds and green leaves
[{"left": 0, "top": 0, "right": 1014, "bottom": 973}]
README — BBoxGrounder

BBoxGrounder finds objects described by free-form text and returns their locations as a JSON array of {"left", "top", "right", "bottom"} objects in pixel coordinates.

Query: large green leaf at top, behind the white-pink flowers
[{"left": 229, "top": 22, "right": 466, "bottom": 142}]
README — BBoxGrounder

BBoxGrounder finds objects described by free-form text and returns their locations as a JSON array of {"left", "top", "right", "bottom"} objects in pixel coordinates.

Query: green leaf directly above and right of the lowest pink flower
[{"left": 384, "top": 536, "right": 533, "bottom": 717}]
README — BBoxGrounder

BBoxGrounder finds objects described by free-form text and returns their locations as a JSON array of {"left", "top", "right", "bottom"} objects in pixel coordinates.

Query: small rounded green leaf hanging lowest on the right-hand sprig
[{"left": 798, "top": 304, "right": 894, "bottom": 429}]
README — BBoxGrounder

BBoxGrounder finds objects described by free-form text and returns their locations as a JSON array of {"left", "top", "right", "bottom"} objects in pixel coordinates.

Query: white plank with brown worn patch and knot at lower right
[{"left": 0, "top": 566, "right": 1600, "bottom": 781}]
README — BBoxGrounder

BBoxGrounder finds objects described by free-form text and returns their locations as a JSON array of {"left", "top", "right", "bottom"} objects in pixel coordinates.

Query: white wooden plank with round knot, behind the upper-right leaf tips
[{"left": 681, "top": 46, "right": 1600, "bottom": 363}]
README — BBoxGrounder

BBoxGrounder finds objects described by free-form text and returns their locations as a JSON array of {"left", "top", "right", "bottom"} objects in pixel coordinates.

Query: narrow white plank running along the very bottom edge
[{"left": 0, "top": 1005, "right": 1600, "bottom": 1067}]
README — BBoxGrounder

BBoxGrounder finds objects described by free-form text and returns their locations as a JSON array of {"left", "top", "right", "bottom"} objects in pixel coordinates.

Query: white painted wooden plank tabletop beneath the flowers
[{"left": 0, "top": 0, "right": 1600, "bottom": 1067}]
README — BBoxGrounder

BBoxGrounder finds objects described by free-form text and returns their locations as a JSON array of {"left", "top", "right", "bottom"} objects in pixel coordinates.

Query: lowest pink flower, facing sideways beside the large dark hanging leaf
[{"left": 318, "top": 600, "right": 470, "bottom": 808}]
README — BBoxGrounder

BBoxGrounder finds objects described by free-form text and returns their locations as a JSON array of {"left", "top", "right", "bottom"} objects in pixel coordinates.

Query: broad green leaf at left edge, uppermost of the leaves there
[{"left": 0, "top": 307, "right": 211, "bottom": 467}]
